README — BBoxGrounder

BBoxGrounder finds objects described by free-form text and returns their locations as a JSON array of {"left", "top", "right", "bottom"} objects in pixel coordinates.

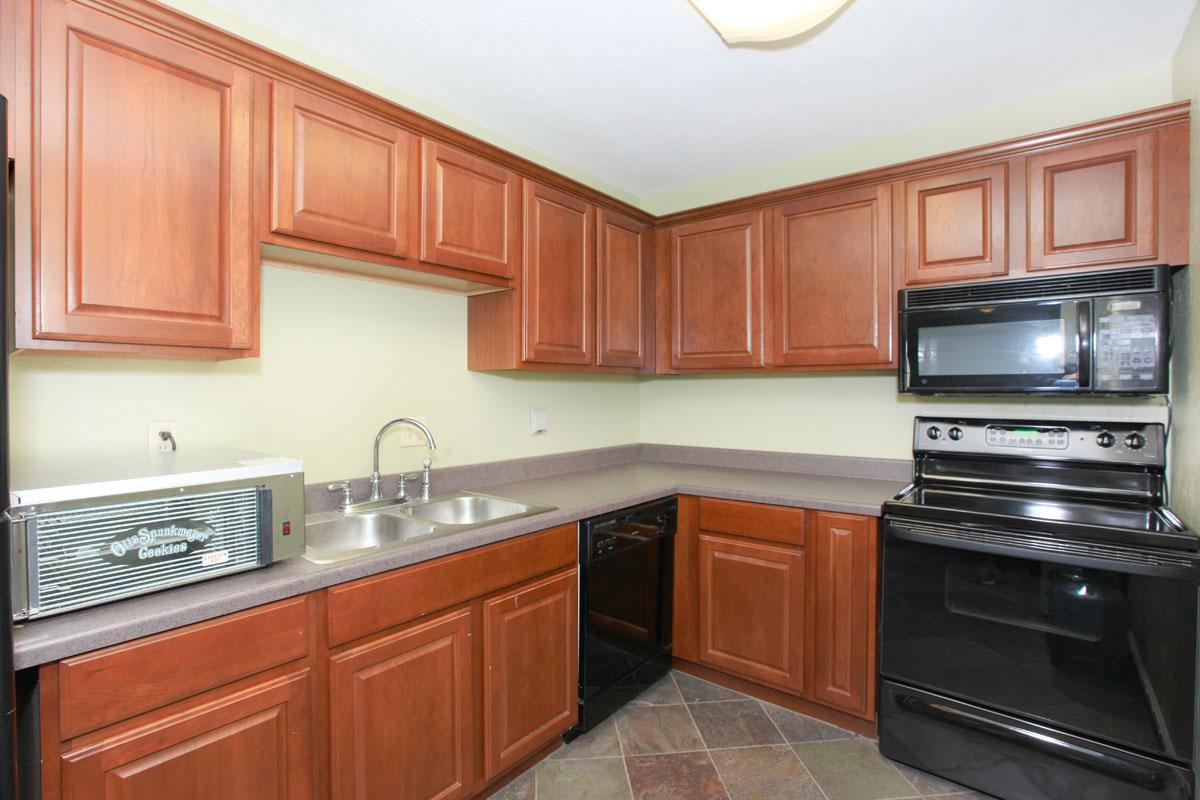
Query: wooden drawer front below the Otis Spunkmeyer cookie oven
[{"left": 59, "top": 597, "right": 308, "bottom": 739}]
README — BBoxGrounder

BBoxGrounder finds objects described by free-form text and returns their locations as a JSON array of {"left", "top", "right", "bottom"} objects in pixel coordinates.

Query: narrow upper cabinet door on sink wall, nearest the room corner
[{"left": 596, "top": 209, "right": 650, "bottom": 368}]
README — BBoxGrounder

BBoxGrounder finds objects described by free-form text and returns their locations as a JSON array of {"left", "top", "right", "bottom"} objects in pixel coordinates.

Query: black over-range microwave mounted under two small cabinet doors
[{"left": 900, "top": 265, "right": 1171, "bottom": 395}]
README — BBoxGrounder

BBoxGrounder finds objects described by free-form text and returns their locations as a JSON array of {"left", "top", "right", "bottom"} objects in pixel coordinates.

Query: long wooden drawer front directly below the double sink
[{"left": 329, "top": 524, "right": 578, "bottom": 646}]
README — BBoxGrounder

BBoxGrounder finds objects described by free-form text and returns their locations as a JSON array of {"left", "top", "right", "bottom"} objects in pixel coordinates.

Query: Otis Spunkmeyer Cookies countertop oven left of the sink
[{"left": 8, "top": 450, "right": 305, "bottom": 619}]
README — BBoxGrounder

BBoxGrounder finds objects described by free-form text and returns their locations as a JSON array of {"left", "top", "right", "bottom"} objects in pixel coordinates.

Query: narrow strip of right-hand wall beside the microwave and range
[{"left": 1171, "top": 11, "right": 1200, "bottom": 527}]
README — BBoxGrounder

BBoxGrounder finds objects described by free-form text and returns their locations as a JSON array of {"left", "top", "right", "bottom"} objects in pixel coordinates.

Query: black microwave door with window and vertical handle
[{"left": 900, "top": 300, "right": 1092, "bottom": 393}]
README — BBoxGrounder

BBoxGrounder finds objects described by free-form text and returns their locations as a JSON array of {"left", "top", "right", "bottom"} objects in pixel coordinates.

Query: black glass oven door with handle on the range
[{"left": 880, "top": 519, "right": 1196, "bottom": 764}]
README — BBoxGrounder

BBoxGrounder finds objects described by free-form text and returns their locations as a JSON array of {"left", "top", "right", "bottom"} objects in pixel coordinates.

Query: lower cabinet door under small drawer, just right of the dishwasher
[{"left": 700, "top": 534, "right": 805, "bottom": 691}]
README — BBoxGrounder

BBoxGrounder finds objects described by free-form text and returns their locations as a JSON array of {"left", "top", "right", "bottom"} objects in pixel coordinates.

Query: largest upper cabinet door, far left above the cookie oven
[{"left": 32, "top": 0, "right": 258, "bottom": 350}]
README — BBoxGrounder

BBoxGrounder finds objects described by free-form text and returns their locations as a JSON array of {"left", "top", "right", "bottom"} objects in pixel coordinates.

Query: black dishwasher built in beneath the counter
[{"left": 566, "top": 498, "right": 678, "bottom": 739}]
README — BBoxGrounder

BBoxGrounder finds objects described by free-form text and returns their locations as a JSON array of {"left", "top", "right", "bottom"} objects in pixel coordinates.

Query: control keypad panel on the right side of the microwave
[{"left": 1093, "top": 295, "right": 1166, "bottom": 392}]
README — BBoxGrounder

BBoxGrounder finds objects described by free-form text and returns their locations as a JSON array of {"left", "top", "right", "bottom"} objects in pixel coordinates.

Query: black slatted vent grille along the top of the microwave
[{"left": 904, "top": 266, "right": 1159, "bottom": 308}]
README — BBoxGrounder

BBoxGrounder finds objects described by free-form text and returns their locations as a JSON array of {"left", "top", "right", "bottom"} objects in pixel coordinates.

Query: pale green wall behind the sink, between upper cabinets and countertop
[{"left": 10, "top": 266, "right": 638, "bottom": 481}]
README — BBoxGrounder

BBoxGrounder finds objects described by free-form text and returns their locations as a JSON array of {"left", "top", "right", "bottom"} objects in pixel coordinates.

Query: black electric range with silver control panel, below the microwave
[{"left": 878, "top": 417, "right": 1200, "bottom": 800}]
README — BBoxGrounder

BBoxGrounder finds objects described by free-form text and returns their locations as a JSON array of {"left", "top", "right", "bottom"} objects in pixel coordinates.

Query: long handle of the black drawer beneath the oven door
[{"left": 896, "top": 694, "right": 1166, "bottom": 789}]
